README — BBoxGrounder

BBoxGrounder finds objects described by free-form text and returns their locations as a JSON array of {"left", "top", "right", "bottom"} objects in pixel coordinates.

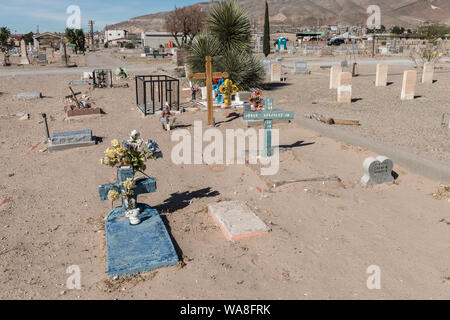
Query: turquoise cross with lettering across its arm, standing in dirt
[{"left": 243, "top": 98, "right": 294, "bottom": 157}]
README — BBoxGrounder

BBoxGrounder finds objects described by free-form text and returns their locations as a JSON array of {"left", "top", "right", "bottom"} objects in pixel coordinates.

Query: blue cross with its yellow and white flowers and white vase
[{"left": 99, "top": 130, "right": 158, "bottom": 225}]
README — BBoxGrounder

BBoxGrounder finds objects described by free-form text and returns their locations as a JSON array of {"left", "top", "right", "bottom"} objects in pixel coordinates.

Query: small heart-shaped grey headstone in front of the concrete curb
[{"left": 361, "top": 156, "right": 394, "bottom": 186}]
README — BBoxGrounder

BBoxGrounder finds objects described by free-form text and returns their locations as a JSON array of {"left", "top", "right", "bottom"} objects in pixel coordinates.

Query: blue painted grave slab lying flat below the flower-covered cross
[{"left": 105, "top": 204, "right": 178, "bottom": 277}]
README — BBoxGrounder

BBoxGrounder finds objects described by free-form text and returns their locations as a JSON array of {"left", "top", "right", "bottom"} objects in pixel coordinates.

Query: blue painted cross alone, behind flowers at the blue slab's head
[{"left": 98, "top": 168, "right": 156, "bottom": 209}]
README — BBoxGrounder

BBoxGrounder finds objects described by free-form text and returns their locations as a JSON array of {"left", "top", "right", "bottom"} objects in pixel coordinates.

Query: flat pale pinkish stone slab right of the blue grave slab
[{"left": 208, "top": 201, "right": 270, "bottom": 241}]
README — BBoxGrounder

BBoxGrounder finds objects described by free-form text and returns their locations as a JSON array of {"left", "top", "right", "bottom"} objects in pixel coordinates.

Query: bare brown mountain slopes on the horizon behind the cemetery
[{"left": 105, "top": 0, "right": 450, "bottom": 33}]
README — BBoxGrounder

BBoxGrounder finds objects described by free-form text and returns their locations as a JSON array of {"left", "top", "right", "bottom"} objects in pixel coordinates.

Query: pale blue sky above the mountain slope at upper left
[{"left": 0, "top": 0, "right": 200, "bottom": 33}]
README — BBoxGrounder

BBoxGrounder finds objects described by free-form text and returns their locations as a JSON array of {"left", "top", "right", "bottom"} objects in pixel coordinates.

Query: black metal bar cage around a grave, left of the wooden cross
[{"left": 135, "top": 75, "right": 180, "bottom": 116}]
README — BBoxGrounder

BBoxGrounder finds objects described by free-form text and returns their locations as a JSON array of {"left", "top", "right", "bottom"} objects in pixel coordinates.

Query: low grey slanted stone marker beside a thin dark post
[{"left": 48, "top": 129, "right": 95, "bottom": 152}]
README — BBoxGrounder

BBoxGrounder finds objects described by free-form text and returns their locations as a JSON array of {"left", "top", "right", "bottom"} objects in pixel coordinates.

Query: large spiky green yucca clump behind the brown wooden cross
[{"left": 187, "top": 0, "right": 264, "bottom": 90}]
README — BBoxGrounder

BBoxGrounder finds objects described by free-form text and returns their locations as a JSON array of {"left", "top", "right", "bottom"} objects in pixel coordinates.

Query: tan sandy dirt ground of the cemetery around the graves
[{"left": 0, "top": 53, "right": 450, "bottom": 299}]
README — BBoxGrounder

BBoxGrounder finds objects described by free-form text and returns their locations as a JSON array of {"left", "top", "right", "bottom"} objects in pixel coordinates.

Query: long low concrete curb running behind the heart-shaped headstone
[{"left": 293, "top": 118, "right": 450, "bottom": 183}]
